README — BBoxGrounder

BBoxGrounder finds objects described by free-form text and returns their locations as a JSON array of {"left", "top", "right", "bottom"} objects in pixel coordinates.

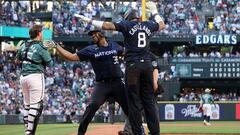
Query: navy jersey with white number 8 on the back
[{"left": 114, "top": 21, "right": 159, "bottom": 61}]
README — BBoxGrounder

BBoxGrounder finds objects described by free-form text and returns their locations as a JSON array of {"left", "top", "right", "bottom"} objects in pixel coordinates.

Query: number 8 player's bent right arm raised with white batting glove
[{"left": 146, "top": 1, "right": 165, "bottom": 30}]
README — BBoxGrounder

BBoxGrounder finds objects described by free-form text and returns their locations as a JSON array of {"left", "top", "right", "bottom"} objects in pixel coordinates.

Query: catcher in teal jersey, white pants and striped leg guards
[{"left": 16, "top": 25, "right": 53, "bottom": 135}]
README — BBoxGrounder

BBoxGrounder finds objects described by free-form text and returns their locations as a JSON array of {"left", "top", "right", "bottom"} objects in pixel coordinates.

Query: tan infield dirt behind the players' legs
[{"left": 69, "top": 123, "right": 239, "bottom": 135}]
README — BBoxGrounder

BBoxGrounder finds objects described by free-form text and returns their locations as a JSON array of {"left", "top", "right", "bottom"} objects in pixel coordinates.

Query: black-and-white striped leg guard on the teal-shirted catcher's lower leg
[{"left": 27, "top": 101, "right": 43, "bottom": 135}]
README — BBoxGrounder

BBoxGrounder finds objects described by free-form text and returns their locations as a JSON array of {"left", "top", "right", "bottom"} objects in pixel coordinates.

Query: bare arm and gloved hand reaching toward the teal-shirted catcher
[{"left": 43, "top": 40, "right": 80, "bottom": 61}]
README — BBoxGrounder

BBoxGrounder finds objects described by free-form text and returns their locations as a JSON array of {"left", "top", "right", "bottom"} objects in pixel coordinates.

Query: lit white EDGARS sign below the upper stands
[{"left": 196, "top": 35, "right": 237, "bottom": 45}]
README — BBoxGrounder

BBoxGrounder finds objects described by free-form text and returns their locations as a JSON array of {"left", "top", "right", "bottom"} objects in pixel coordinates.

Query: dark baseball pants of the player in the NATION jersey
[{"left": 78, "top": 79, "right": 128, "bottom": 135}]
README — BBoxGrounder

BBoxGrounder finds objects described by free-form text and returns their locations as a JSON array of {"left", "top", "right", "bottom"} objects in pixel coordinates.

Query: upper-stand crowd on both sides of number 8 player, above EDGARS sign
[{"left": 53, "top": 0, "right": 240, "bottom": 35}]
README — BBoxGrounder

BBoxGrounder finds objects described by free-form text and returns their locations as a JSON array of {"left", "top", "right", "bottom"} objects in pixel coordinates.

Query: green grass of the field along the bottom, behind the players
[{"left": 0, "top": 121, "right": 240, "bottom": 135}]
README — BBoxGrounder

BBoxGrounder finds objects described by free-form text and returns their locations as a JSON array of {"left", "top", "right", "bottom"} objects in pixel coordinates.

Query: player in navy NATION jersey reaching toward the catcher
[{"left": 43, "top": 30, "right": 128, "bottom": 135}]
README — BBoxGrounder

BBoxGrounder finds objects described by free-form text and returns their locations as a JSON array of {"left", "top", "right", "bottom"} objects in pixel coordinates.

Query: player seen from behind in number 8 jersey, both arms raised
[{"left": 75, "top": 2, "right": 165, "bottom": 135}]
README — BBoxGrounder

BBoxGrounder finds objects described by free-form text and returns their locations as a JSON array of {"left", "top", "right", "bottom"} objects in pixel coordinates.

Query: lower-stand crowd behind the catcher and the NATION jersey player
[{"left": 0, "top": 52, "right": 122, "bottom": 120}]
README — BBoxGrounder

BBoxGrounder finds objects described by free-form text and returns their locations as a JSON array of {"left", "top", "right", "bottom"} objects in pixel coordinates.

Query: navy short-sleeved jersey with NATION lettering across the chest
[{"left": 77, "top": 42, "right": 123, "bottom": 81}]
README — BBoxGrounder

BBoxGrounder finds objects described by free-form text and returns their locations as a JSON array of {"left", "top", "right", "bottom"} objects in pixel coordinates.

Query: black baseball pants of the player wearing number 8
[{"left": 126, "top": 61, "right": 160, "bottom": 135}]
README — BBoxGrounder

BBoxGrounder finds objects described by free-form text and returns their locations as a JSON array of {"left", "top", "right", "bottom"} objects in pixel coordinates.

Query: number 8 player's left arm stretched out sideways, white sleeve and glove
[{"left": 74, "top": 14, "right": 116, "bottom": 30}]
